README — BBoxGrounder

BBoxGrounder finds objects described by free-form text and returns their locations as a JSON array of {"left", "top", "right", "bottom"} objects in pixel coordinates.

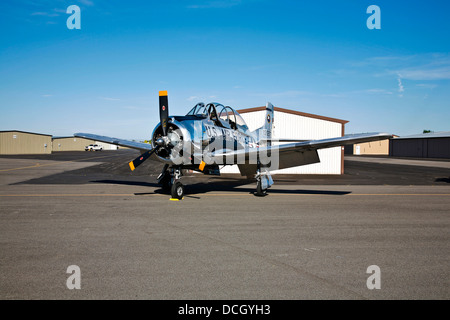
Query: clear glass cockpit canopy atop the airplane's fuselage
[{"left": 187, "top": 102, "right": 248, "bottom": 131}]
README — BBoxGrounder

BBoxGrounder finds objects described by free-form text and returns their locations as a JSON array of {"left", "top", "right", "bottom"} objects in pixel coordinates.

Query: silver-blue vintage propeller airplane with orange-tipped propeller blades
[{"left": 74, "top": 91, "right": 392, "bottom": 200}]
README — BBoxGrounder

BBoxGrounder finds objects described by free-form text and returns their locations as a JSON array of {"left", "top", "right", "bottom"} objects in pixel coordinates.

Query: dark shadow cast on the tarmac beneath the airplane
[{"left": 91, "top": 180, "right": 351, "bottom": 198}]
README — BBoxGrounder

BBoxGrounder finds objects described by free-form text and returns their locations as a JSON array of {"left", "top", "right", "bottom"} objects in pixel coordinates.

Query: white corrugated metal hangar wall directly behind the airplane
[{"left": 221, "top": 110, "right": 342, "bottom": 174}]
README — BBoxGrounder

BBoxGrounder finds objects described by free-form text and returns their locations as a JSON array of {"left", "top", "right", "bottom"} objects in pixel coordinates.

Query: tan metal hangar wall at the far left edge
[{"left": 0, "top": 131, "right": 52, "bottom": 154}]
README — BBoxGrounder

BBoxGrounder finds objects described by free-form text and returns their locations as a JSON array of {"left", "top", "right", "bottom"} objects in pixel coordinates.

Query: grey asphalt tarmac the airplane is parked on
[{"left": 0, "top": 150, "right": 450, "bottom": 300}]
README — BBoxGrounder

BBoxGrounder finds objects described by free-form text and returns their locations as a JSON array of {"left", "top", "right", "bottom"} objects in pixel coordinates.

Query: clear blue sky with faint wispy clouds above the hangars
[{"left": 0, "top": 0, "right": 450, "bottom": 139}]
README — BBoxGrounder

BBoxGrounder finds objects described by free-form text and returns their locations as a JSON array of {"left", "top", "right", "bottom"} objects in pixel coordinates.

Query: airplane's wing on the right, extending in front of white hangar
[{"left": 210, "top": 133, "right": 392, "bottom": 172}]
